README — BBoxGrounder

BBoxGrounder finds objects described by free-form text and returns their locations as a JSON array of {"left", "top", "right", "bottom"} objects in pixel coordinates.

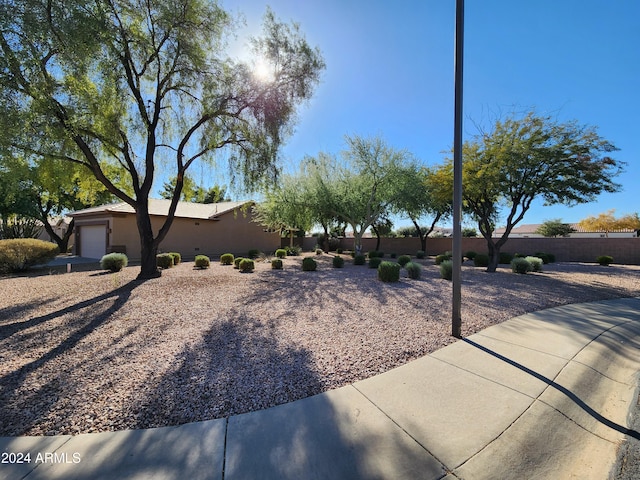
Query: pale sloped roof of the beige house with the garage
[{"left": 68, "top": 198, "right": 251, "bottom": 220}]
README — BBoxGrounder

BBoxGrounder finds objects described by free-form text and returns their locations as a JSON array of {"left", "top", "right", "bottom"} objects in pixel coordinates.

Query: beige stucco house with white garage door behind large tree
[{"left": 69, "top": 199, "right": 280, "bottom": 260}]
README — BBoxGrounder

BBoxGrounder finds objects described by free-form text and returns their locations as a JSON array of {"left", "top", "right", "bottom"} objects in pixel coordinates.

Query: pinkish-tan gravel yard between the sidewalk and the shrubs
[{"left": 0, "top": 255, "right": 640, "bottom": 436}]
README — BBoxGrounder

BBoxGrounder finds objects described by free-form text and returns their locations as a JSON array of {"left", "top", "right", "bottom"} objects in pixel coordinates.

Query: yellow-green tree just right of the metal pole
[{"left": 449, "top": 112, "right": 622, "bottom": 272}]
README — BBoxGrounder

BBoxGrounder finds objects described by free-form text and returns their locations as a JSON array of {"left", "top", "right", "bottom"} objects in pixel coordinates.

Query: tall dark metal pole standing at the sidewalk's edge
[{"left": 451, "top": 0, "right": 464, "bottom": 338}]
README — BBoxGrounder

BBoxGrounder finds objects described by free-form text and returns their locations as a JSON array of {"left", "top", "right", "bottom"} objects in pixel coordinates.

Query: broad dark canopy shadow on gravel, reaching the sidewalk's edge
[{"left": 131, "top": 309, "right": 323, "bottom": 428}]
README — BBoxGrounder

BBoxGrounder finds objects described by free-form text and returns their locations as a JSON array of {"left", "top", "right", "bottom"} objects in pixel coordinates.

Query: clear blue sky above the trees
[{"left": 201, "top": 0, "right": 640, "bottom": 229}]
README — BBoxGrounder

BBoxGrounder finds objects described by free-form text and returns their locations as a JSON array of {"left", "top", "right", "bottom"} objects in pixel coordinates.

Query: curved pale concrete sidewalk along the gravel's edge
[{"left": 0, "top": 298, "right": 640, "bottom": 480}]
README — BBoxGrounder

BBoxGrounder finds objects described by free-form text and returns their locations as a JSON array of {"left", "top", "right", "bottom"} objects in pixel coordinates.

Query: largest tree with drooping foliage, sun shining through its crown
[{"left": 0, "top": 0, "right": 324, "bottom": 278}]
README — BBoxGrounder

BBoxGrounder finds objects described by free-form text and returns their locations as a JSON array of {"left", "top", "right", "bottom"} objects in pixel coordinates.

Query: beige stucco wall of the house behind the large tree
[{"left": 102, "top": 210, "right": 280, "bottom": 260}]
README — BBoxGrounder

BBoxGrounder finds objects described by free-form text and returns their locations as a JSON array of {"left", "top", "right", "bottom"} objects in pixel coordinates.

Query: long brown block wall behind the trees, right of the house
[{"left": 282, "top": 237, "right": 640, "bottom": 265}]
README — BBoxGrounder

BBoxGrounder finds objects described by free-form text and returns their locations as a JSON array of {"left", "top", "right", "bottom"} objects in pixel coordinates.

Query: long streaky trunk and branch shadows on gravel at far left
[{"left": 0, "top": 280, "right": 141, "bottom": 435}]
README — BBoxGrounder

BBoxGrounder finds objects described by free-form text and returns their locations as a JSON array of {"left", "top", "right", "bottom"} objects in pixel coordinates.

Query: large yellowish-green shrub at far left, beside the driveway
[{"left": 0, "top": 238, "right": 60, "bottom": 272}]
